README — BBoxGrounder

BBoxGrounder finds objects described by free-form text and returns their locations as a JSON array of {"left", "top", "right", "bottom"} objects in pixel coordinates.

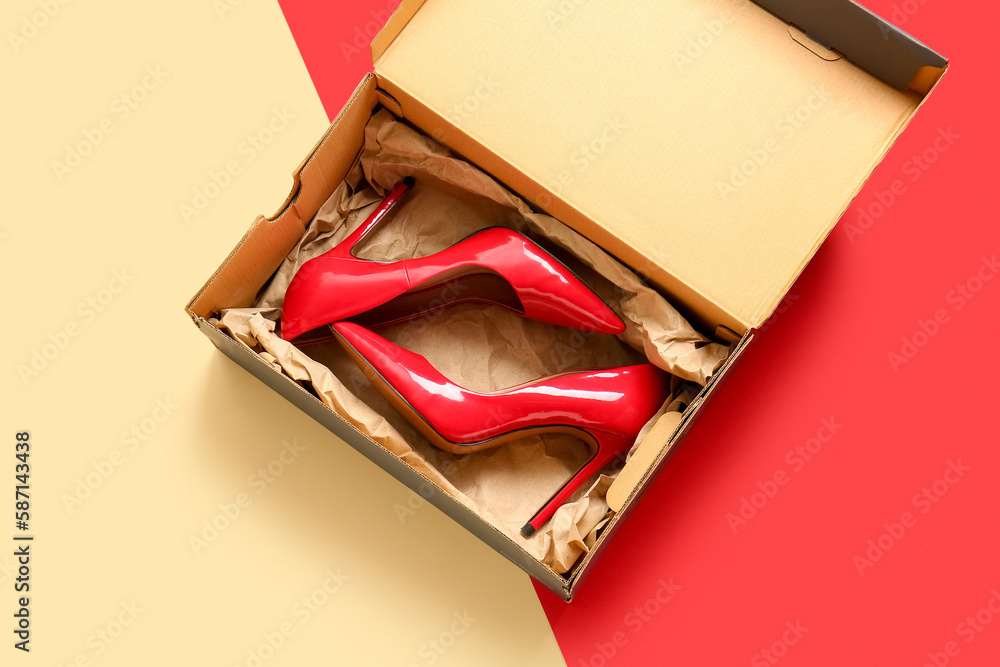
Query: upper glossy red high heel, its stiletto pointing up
[{"left": 281, "top": 178, "right": 625, "bottom": 340}]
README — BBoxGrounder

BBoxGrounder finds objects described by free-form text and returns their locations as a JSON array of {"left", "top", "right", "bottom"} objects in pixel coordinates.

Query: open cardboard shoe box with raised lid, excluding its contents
[{"left": 187, "top": 0, "right": 947, "bottom": 600}]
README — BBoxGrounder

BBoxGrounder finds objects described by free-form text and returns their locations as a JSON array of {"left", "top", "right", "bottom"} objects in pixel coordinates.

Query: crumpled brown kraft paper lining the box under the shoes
[{"left": 215, "top": 110, "right": 729, "bottom": 573}]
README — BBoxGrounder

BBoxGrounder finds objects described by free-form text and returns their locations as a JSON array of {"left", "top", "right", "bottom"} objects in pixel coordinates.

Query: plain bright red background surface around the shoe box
[{"left": 281, "top": 0, "right": 1000, "bottom": 667}]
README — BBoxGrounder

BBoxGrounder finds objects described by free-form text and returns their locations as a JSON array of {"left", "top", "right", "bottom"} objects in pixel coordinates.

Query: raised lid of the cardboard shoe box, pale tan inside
[{"left": 372, "top": 0, "right": 946, "bottom": 333}]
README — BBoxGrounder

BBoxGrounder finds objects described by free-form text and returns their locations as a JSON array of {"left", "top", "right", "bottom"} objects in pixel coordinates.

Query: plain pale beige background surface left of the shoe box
[{"left": 0, "top": 0, "right": 562, "bottom": 667}]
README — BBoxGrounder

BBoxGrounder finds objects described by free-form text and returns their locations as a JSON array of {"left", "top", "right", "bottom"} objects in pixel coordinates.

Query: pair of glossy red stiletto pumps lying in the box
[{"left": 281, "top": 178, "right": 669, "bottom": 535}]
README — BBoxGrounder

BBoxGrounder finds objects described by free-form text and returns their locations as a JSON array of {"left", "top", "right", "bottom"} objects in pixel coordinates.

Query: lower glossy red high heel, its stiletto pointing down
[{"left": 331, "top": 322, "right": 670, "bottom": 535}]
